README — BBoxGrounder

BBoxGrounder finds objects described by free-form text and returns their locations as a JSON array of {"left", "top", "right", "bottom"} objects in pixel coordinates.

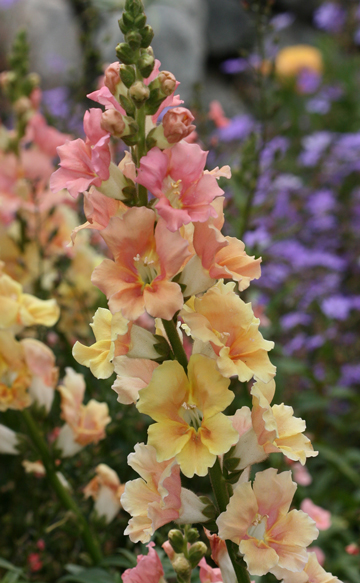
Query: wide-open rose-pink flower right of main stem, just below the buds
[{"left": 137, "top": 141, "right": 223, "bottom": 231}]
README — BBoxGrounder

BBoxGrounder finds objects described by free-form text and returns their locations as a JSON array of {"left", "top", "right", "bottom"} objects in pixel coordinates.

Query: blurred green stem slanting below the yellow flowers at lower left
[{"left": 22, "top": 409, "right": 102, "bottom": 564}]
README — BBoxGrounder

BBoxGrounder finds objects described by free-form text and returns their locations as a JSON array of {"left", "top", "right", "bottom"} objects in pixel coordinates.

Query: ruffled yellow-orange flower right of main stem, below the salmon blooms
[{"left": 180, "top": 280, "right": 276, "bottom": 383}]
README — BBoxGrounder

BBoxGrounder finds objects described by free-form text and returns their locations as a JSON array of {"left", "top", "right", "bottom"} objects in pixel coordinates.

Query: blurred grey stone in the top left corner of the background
[{"left": 0, "top": 0, "right": 82, "bottom": 89}]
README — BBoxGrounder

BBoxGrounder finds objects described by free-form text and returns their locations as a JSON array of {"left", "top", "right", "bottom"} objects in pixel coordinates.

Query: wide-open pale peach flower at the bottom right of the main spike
[{"left": 216, "top": 468, "right": 318, "bottom": 575}]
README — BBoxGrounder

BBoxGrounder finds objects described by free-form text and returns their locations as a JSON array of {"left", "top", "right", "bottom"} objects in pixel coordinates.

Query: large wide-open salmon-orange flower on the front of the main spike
[{"left": 92, "top": 207, "right": 190, "bottom": 320}]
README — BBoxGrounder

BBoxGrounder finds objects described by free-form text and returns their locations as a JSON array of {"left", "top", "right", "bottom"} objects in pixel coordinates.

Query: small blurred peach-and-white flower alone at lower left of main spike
[{"left": 84, "top": 464, "right": 125, "bottom": 524}]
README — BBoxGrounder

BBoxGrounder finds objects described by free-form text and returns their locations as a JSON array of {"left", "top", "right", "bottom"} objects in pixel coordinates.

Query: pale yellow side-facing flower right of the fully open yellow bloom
[{"left": 232, "top": 379, "right": 318, "bottom": 470}]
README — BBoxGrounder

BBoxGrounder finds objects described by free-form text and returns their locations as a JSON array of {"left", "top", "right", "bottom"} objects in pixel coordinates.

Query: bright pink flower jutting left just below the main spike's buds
[{"left": 50, "top": 109, "right": 111, "bottom": 198}]
